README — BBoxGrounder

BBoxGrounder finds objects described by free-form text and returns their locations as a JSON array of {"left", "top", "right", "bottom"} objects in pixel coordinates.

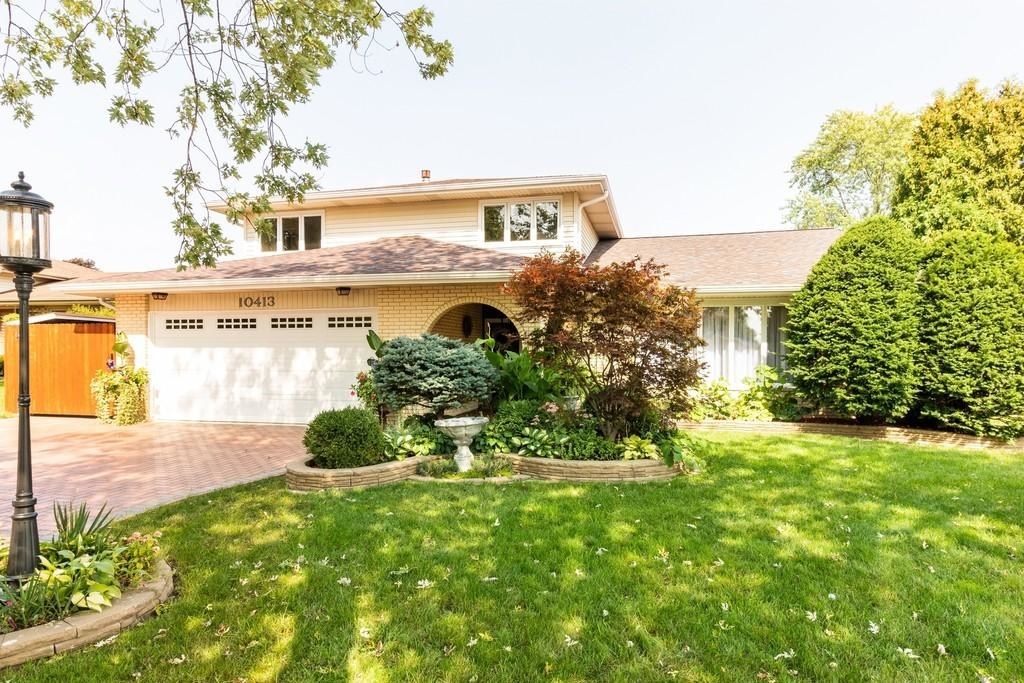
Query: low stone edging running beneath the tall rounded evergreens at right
[{"left": 676, "top": 420, "right": 1024, "bottom": 453}]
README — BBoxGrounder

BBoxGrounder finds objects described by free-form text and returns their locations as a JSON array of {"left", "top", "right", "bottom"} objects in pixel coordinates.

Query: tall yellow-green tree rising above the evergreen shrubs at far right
[{"left": 893, "top": 81, "right": 1024, "bottom": 245}]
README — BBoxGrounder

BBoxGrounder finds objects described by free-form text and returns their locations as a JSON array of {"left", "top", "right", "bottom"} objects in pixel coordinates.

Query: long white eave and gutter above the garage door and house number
[{"left": 61, "top": 270, "right": 512, "bottom": 296}]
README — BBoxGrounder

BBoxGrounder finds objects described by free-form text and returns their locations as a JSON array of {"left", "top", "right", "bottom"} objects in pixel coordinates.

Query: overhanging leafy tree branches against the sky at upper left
[{"left": 0, "top": 0, "right": 454, "bottom": 267}]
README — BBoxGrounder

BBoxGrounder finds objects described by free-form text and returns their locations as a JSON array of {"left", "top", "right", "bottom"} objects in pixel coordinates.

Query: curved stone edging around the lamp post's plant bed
[{"left": 0, "top": 560, "right": 174, "bottom": 669}]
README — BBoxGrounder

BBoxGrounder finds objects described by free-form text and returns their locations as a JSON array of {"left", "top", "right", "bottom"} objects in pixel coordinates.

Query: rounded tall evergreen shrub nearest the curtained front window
[{"left": 786, "top": 217, "right": 920, "bottom": 422}]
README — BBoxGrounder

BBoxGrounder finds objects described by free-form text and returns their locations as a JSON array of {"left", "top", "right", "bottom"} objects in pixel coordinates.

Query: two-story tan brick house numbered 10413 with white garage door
[{"left": 56, "top": 175, "right": 836, "bottom": 423}]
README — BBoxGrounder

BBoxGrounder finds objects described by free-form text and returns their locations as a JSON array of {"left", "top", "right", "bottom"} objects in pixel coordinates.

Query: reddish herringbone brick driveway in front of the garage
[{"left": 0, "top": 417, "right": 305, "bottom": 539}]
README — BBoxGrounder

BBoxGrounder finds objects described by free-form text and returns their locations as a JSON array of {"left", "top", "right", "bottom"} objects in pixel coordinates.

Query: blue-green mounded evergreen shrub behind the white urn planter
[{"left": 373, "top": 334, "right": 498, "bottom": 415}]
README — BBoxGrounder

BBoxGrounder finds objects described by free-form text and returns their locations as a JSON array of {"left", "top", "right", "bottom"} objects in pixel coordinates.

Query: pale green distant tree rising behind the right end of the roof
[{"left": 785, "top": 104, "right": 914, "bottom": 228}]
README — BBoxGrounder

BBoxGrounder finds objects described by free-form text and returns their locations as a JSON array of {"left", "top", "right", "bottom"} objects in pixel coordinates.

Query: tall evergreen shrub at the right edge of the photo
[{"left": 920, "top": 230, "right": 1024, "bottom": 437}]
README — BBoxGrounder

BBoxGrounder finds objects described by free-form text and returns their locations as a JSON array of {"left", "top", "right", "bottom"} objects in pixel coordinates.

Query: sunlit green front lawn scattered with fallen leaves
[{"left": 9, "top": 435, "right": 1024, "bottom": 682}]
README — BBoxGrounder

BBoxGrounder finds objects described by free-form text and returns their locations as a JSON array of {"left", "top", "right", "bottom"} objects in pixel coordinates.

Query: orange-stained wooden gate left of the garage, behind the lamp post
[{"left": 4, "top": 319, "right": 114, "bottom": 416}]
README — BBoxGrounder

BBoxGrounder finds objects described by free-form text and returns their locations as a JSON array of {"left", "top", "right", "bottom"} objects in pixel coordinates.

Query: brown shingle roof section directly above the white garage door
[{"left": 70, "top": 237, "right": 522, "bottom": 286}]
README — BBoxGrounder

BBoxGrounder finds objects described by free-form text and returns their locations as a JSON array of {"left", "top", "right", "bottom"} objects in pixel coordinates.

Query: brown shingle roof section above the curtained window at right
[{"left": 588, "top": 229, "right": 842, "bottom": 290}]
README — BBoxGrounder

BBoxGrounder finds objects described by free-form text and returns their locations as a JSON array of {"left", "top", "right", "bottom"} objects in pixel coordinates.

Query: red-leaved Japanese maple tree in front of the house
[{"left": 505, "top": 250, "right": 703, "bottom": 439}]
